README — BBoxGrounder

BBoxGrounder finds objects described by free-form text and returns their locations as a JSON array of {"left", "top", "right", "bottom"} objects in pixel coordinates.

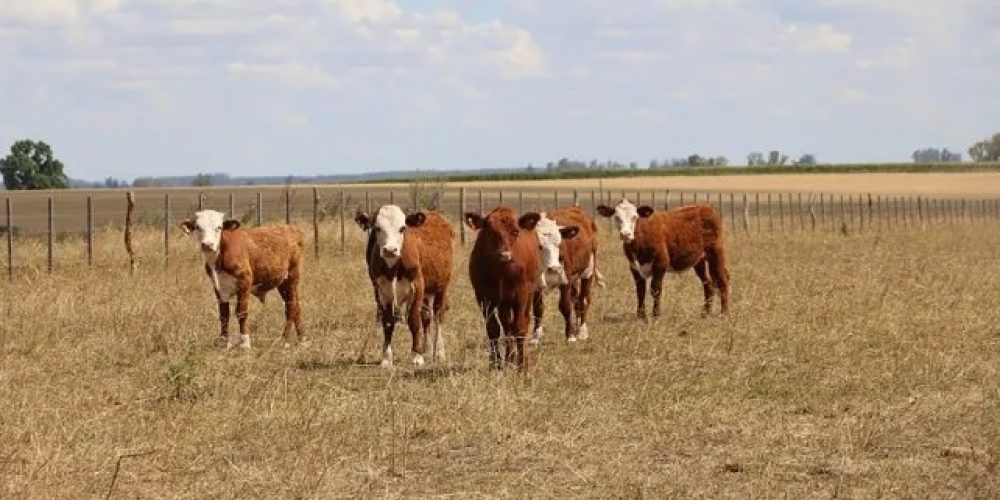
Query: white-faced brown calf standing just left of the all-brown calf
[{"left": 354, "top": 205, "right": 455, "bottom": 368}]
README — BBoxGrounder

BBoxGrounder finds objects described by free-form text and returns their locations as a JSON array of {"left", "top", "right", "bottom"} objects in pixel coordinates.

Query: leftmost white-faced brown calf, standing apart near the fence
[{"left": 181, "top": 210, "right": 308, "bottom": 349}]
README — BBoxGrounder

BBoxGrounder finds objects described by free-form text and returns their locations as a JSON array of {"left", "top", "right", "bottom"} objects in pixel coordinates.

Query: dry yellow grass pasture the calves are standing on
[{"left": 0, "top": 226, "right": 1000, "bottom": 498}]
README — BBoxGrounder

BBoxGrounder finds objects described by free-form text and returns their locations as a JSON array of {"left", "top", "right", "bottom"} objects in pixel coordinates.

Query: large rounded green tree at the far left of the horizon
[{"left": 0, "top": 139, "right": 69, "bottom": 190}]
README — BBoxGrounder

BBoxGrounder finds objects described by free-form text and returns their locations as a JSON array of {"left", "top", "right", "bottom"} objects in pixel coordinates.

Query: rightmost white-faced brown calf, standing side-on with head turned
[{"left": 597, "top": 199, "right": 729, "bottom": 318}]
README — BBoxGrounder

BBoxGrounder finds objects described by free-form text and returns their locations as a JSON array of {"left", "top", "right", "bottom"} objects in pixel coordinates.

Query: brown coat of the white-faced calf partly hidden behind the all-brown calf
[{"left": 534, "top": 205, "right": 600, "bottom": 341}]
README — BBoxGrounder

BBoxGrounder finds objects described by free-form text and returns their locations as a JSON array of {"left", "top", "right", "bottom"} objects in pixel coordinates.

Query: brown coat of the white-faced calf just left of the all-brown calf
[{"left": 355, "top": 207, "right": 455, "bottom": 367}]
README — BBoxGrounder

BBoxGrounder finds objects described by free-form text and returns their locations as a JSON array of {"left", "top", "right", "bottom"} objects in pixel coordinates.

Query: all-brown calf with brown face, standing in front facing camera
[{"left": 465, "top": 207, "right": 541, "bottom": 370}]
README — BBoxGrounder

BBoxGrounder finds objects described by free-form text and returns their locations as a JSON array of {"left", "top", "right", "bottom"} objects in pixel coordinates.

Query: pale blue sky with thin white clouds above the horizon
[{"left": 0, "top": 0, "right": 1000, "bottom": 180}]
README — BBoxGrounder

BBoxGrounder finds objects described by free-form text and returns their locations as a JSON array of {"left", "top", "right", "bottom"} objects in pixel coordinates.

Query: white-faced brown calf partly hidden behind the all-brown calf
[{"left": 531, "top": 205, "right": 601, "bottom": 343}]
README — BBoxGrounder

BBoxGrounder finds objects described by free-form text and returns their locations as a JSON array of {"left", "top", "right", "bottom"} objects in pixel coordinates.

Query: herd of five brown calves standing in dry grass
[{"left": 181, "top": 199, "right": 729, "bottom": 369}]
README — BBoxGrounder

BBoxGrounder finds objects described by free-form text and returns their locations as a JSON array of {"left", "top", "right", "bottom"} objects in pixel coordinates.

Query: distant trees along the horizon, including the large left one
[{"left": 0, "top": 132, "right": 1000, "bottom": 191}]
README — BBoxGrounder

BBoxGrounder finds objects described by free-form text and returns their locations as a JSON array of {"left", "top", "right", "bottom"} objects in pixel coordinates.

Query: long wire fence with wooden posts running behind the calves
[{"left": 0, "top": 184, "right": 1000, "bottom": 279}]
